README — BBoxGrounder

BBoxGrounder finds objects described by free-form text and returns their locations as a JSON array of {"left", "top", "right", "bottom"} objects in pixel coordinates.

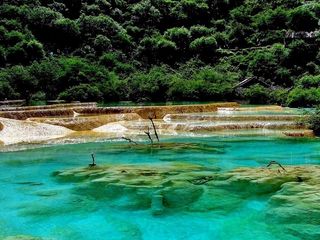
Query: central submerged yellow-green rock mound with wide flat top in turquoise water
[{"left": 54, "top": 163, "right": 218, "bottom": 212}]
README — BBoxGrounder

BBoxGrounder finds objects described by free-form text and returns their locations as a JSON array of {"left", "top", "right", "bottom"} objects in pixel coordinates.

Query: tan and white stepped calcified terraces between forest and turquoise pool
[{"left": 0, "top": 102, "right": 312, "bottom": 145}]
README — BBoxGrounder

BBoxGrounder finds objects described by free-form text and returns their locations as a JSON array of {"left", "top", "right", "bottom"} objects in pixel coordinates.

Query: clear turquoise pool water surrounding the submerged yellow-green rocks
[{"left": 0, "top": 137, "right": 320, "bottom": 240}]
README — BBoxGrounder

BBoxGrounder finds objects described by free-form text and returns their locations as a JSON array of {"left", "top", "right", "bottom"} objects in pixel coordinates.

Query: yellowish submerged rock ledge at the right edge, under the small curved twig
[{"left": 212, "top": 165, "right": 320, "bottom": 234}]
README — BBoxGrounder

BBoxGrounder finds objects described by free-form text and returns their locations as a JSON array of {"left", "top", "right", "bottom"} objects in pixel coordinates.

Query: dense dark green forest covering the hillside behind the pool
[{"left": 0, "top": 0, "right": 320, "bottom": 107}]
